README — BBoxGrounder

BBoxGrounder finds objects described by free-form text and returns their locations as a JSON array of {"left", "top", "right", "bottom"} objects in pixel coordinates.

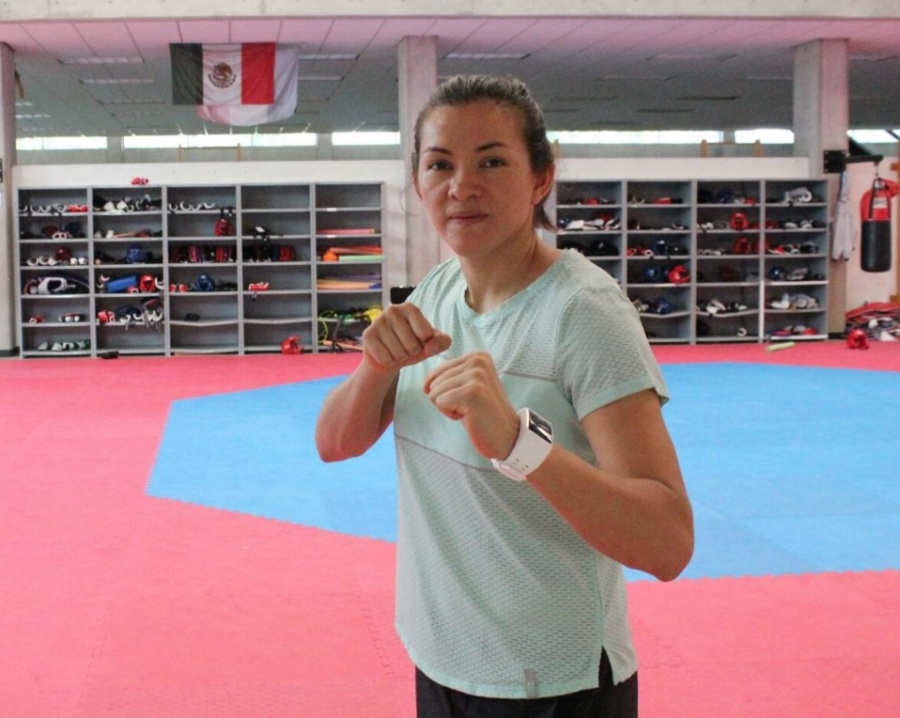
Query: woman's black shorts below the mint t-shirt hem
[{"left": 416, "top": 651, "right": 638, "bottom": 718}]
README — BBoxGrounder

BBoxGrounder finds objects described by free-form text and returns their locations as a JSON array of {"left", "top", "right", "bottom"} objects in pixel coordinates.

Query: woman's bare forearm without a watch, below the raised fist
[{"left": 316, "top": 360, "right": 399, "bottom": 461}]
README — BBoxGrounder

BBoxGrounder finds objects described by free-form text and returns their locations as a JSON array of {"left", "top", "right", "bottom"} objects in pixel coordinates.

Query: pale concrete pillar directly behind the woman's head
[{"left": 397, "top": 37, "right": 441, "bottom": 285}]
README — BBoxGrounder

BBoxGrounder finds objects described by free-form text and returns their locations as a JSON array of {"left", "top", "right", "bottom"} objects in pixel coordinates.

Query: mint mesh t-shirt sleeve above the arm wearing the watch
[{"left": 556, "top": 286, "right": 668, "bottom": 420}]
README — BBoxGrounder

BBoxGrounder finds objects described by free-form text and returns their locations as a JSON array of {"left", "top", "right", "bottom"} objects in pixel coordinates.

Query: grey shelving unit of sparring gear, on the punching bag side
[{"left": 553, "top": 179, "right": 829, "bottom": 343}]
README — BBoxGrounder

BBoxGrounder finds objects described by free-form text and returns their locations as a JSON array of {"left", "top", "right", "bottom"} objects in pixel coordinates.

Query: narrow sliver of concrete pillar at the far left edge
[{"left": 0, "top": 43, "right": 18, "bottom": 356}]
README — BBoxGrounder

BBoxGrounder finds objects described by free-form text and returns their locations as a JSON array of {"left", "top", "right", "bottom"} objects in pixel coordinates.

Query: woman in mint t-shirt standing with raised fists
[{"left": 316, "top": 76, "right": 693, "bottom": 718}]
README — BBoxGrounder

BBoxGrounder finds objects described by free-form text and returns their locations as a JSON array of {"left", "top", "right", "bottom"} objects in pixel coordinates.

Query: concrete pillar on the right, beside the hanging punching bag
[{"left": 794, "top": 39, "right": 850, "bottom": 334}]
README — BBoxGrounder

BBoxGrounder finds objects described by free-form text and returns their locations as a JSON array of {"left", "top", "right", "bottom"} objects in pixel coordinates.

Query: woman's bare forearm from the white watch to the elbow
[{"left": 528, "top": 445, "right": 694, "bottom": 581}]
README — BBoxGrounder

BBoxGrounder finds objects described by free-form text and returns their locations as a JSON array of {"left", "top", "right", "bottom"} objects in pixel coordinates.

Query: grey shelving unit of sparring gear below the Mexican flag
[{"left": 16, "top": 181, "right": 386, "bottom": 357}]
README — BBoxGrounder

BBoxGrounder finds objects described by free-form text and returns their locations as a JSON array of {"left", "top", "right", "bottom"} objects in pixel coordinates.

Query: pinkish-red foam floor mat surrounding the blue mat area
[{"left": 0, "top": 342, "right": 900, "bottom": 718}]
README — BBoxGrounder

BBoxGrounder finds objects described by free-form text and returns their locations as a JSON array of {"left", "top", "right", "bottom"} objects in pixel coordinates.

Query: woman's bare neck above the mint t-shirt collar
[{"left": 460, "top": 232, "right": 559, "bottom": 314}]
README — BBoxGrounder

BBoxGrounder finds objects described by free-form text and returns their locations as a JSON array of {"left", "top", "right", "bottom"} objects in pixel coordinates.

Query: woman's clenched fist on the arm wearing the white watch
[{"left": 424, "top": 352, "right": 519, "bottom": 459}]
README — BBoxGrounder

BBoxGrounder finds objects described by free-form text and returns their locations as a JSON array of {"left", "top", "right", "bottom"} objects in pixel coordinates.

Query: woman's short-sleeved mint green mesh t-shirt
[{"left": 394, "top": 251, "right": 667, "bottom": 698}]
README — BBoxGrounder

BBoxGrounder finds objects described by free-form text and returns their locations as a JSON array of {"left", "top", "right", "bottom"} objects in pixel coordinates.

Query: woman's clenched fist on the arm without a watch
[{"left": 362, "top": 302, "right": 452, "bottom": 374}]
